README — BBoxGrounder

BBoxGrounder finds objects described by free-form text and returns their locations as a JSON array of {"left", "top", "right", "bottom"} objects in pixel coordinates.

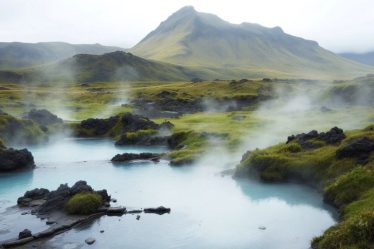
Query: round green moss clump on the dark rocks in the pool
[{"left": 65, "top": 192, "right": 103, "bottom": 215}]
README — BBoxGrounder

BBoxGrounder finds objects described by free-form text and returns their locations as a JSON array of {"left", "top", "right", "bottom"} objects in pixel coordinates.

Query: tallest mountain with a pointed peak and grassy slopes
[{"left": 130, "top": 7, "right": 374, "bottom": 78}]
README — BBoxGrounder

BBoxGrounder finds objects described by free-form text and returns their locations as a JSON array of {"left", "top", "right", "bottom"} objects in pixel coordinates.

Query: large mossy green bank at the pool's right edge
[{"left": 236, "top": 126, "right": 374, "bottom": 249}]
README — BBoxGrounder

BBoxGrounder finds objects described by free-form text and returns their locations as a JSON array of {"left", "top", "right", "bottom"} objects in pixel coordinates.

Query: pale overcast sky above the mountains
[{"left": 0, "top": 0, "right": 374, "bottom": 52}]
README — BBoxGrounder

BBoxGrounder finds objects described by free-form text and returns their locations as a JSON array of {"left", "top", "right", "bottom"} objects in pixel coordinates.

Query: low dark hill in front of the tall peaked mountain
[{"left": 0, "top": 51, "right": 207, "bottom": 83}]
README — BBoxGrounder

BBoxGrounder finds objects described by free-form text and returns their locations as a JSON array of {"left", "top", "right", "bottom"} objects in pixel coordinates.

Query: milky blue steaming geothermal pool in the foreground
[{"left": 0, "top": 139, "right": 335, "bottom": 249}]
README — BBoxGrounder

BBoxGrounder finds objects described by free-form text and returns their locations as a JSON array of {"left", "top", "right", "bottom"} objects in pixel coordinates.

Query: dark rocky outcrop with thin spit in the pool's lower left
[{"left": 0, "top": 181, "right": 171, "bottom": 248}]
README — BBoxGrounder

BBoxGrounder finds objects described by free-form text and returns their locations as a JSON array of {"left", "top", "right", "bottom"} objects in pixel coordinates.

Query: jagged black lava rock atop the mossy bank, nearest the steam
[{"left": 287, "top": 127, "right": 346, "bottom": 149}]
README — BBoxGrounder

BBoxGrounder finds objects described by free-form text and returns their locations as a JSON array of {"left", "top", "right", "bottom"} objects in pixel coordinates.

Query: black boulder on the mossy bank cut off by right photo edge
[{"left": 336, "top": 137, "right": 374, "bottom": 165}]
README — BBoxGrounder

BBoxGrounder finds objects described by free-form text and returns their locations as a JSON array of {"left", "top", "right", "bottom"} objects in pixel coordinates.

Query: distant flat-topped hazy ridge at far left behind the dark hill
[{"left": 0, "top": 42, "right": 122, "bottom": 70}]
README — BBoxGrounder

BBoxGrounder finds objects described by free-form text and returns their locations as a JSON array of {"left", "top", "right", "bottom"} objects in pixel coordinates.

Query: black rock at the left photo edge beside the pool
[{"left": 0, "top": 148, "right": 35, "bottom": 172}]
